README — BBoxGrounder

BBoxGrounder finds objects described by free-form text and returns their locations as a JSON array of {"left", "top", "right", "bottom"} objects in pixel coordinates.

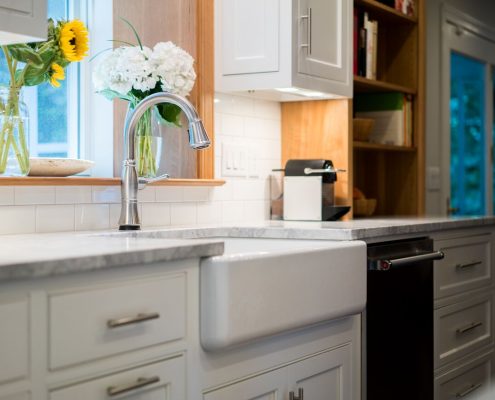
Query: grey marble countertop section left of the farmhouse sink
[{"left": 0, "top": 233, "right": 224, "bottom": 282}]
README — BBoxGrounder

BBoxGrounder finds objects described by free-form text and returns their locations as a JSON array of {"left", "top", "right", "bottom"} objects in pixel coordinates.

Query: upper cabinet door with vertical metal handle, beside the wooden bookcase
[{"left": 297, "top": 0, "right": 351, "bottom": 82}]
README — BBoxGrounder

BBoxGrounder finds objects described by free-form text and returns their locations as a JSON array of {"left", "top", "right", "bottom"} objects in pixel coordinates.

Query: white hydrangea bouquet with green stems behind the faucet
[{"left": 93, "top": 21, "right": 196, "bottom": 177}]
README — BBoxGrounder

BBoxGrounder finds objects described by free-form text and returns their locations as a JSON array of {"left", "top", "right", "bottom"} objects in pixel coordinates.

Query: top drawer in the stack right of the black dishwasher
[{"left": 434, "top": 234, "right": 492, "bottom": 299}]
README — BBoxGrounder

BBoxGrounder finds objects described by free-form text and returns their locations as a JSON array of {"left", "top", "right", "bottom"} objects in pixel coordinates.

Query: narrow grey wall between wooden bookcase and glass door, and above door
[{"left": 425, "top": 0, "right": 495, "bottom": 215}]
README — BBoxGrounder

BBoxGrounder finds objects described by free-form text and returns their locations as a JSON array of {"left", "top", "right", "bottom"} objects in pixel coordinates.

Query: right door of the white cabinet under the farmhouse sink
[{"left": 288, "top": 345, "right": 353, "bottom": 400}]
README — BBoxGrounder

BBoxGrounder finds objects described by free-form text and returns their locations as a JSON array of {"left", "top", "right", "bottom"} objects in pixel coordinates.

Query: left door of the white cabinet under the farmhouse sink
[{"left": 204, "top": 368, "right": 288, "bottom": 400}]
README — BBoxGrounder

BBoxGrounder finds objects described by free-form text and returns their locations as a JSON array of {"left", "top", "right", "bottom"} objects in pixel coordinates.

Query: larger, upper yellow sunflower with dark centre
[{"left": 59, "top": 19, "right": 89, "bottom": 62}]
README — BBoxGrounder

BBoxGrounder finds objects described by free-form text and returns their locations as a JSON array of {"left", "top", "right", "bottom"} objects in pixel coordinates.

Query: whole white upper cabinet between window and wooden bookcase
[{"left": 215, "top": 0, "right": 352, "bottom": 101}]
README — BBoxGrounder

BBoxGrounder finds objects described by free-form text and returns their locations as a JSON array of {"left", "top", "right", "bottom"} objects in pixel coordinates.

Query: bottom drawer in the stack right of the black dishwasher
[{"left": 435, "top": 353, "right": 494, "bottom": 400}]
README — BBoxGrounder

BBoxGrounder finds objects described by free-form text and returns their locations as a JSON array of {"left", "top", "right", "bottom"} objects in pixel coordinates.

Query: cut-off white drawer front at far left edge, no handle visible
[{"left": 0, "top": 299, "right": 29, "bottom": 382}]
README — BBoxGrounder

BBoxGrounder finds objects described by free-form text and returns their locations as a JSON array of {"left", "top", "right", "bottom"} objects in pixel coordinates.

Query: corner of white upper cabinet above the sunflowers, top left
[{"left": 0, "top": 0, "right": 47, "bottom": 45}]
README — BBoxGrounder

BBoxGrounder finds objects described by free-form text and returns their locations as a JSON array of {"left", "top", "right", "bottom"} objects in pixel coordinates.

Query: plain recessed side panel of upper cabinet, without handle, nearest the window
[{"left": 217, "top": 0, "right": 280, "bottom": 75}]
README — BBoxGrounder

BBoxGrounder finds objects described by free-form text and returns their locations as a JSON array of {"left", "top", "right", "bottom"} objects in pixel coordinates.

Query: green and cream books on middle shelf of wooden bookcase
[{"left": 354, "top": 92, "right": 413, "bottom": 147}]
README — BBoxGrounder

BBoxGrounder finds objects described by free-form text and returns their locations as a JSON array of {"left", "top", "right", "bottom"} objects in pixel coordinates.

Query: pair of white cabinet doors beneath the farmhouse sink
[{"left": 204, "top": 345, "right": 352, "bottom": 400}]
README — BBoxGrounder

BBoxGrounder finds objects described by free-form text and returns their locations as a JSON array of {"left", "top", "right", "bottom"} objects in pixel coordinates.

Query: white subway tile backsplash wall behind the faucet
[{"left": 0, "top": 94, "right": 281, "bottom": 234}]
